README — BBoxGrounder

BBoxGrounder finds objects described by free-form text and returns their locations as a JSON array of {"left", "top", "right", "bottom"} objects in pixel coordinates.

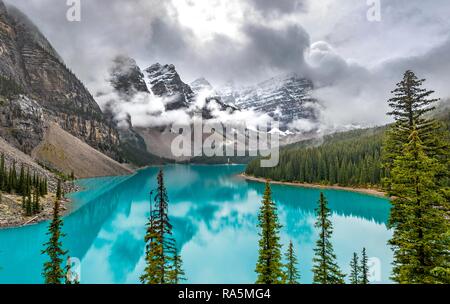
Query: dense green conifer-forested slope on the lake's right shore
[{"left": 246, "top": 107, "right": 450, "bottom": 187}]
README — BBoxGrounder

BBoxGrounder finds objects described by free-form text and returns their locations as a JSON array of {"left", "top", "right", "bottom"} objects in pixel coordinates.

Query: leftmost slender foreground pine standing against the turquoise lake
[{"left": 42, "top": 200, "right": 67, "bottom": 284}]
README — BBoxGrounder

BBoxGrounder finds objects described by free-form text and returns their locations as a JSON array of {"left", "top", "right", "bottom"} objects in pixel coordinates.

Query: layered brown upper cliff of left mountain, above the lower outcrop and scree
[{"left": 0, "top": 0, "right": 121, "bottom": 159}]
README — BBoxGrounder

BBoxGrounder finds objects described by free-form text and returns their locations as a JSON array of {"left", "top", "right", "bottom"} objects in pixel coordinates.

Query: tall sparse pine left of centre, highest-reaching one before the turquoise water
[{"left": 141, "top": 170, "right": 176, "bottom": 284}]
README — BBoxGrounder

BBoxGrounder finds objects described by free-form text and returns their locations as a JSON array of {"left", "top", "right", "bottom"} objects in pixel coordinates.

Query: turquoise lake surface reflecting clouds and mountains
[{"left": 0, "top": 165, "right": 392, "bottom": 283}]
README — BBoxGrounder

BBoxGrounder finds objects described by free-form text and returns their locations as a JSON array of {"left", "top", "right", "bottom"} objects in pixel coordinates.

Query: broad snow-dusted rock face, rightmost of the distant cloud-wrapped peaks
[{"left": 218, "top": 74, "right": 318, "bottom": 129}]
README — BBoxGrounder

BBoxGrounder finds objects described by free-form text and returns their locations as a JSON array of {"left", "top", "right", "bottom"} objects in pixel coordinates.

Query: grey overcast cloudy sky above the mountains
[{"left": 6, "top": 0, "right": 450, "bottom": 124}]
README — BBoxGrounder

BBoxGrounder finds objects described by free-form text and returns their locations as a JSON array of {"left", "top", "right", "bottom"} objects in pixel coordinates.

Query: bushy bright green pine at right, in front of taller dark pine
[{"left": 389, "top": 129, "right": 450, "bottom": 284}]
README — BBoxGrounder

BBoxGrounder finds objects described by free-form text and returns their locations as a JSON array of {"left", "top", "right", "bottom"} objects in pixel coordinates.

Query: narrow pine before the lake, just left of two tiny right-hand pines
[{"left": 313, "top": 193, "right": 344, "bottom": 284}]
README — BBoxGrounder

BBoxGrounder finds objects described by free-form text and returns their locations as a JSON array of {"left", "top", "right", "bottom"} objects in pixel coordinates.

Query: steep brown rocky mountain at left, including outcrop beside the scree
[{"left": 0, "top": 0, "right": 130, "bottom": 176}]
